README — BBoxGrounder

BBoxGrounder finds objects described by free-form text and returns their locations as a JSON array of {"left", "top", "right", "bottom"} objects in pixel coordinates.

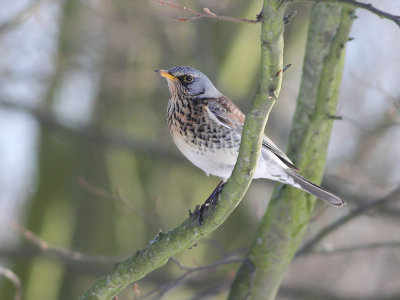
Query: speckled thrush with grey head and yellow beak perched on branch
[{"left": 155, "top": 66, "right": 346, "bottom": 208}]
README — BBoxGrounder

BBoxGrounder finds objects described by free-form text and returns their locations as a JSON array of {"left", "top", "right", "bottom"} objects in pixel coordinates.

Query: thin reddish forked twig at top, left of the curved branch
[{"left": 157, "top": 0, "right": 260, "bottom": 24}]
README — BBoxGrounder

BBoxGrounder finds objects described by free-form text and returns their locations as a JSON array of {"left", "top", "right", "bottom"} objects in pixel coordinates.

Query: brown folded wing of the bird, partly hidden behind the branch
[{"left": 207, "top": 96, "right": 299, "bottom": 171}]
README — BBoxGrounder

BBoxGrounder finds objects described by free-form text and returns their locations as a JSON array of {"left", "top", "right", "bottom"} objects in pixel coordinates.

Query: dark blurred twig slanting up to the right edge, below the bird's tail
[{"left": 296, "top": 187, "right": 400, "bottom": 257}]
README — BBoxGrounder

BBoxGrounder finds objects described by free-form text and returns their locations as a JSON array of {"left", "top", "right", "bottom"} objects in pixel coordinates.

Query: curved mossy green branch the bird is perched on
[{"left": 81, "top": 0, "right": 284, "bottom": 300}]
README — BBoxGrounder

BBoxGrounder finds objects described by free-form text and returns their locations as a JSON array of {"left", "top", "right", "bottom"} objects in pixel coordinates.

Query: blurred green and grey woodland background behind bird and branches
[{"left": 0, "top": 0, "right": 400, "bottom": 299}]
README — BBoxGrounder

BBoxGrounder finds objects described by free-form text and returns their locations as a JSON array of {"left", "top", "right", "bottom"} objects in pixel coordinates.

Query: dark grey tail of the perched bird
[{"left": 286, "top": 169, "right": 346, "bottom": 207}]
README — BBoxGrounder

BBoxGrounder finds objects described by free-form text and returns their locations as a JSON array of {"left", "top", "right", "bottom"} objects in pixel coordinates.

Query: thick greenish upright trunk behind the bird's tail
[{"left": 230, "top": 4, "right": 353, "bottom": 299}]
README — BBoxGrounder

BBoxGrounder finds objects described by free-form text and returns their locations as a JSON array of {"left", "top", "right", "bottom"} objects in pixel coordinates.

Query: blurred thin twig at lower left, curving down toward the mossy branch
[{"left": 10, "top": 222, "right": 120, "bottom": 264}]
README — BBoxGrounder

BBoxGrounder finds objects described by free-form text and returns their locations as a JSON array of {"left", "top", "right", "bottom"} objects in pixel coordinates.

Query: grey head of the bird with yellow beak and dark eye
[{"left": 156, "top": 66, "right": 222, "bottom": 99}]
